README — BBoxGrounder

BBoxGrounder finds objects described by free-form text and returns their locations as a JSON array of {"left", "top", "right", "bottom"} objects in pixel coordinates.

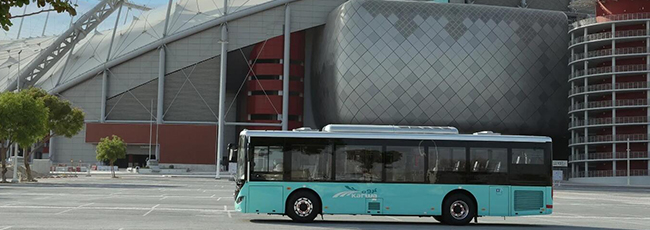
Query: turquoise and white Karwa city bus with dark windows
[{"left": 229, "top": 125, "right": 553, "bottom": 225}]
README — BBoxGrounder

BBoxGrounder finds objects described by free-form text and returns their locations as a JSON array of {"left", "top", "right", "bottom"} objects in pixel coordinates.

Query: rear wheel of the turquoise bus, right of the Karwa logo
[{"left": 442, "top": 193, "right": 476, "bottom": 225}]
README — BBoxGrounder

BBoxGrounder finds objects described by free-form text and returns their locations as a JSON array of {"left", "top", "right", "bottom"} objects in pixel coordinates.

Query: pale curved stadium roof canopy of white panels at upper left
[{"left": 0, "top": 0, "right": 273, "bottom": 90}]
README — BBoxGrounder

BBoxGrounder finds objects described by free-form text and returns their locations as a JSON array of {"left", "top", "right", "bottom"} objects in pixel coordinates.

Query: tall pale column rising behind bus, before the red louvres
[{"left": 282, "top": 4, "right": 291, "bottom": 130}]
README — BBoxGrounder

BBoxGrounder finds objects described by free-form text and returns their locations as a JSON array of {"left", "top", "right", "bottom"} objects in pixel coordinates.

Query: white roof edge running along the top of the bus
[{"left": 240, "top": 129, "right": 552, "bottom": 143}]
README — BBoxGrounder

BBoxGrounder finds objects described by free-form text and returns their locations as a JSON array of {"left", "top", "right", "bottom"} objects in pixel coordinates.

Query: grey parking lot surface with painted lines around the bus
[{"left": 0, "top": 175, "right": 650, "bottom": 230}]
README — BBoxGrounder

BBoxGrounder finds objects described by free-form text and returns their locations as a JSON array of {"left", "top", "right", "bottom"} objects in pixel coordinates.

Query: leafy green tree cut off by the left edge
[{"left": 0, "top": 91, "right": 48, "bottom": 182}]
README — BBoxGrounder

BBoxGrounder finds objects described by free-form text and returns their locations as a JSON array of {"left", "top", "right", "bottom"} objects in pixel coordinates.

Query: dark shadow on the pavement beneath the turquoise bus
[{"left": 250, "top": 219, "right": 614, "bottom": 230}]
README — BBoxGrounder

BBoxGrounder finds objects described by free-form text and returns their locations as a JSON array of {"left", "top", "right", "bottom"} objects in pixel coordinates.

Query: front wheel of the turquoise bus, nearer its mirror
[{"left": 285, "top": 191, "right": 321, "bottom": 223}]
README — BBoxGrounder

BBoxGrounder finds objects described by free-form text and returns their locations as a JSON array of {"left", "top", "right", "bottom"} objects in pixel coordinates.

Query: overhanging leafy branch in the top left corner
[{"left": 0, "top": 0, "right": 77, "bottom": 31}]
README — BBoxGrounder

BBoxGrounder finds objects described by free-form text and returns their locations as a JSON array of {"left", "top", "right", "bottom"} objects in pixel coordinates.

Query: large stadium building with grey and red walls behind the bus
[{"left": 0, "top": 0, "right": 632, "bottom": 185}]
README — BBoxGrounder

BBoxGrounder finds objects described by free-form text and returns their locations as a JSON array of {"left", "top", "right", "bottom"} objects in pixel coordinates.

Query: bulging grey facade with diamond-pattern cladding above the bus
[{"left": 313, "top": 0, "right": 569, "bottom": 136}]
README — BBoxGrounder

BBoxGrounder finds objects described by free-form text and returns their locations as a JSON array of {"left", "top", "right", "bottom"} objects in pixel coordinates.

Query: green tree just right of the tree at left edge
[{"left": 23, "top": 88, "right": 84, "bottom": 181}]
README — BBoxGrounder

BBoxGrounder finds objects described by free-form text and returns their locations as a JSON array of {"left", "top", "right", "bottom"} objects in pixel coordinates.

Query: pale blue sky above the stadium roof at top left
[{"left": 0, "top": 0, "right": 167, "bottom": 40}]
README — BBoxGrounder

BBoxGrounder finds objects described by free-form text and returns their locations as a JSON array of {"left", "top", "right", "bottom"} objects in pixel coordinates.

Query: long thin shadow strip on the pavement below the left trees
[{"left": 0, "top": 182, "right": 180, "bottom": 189}]
